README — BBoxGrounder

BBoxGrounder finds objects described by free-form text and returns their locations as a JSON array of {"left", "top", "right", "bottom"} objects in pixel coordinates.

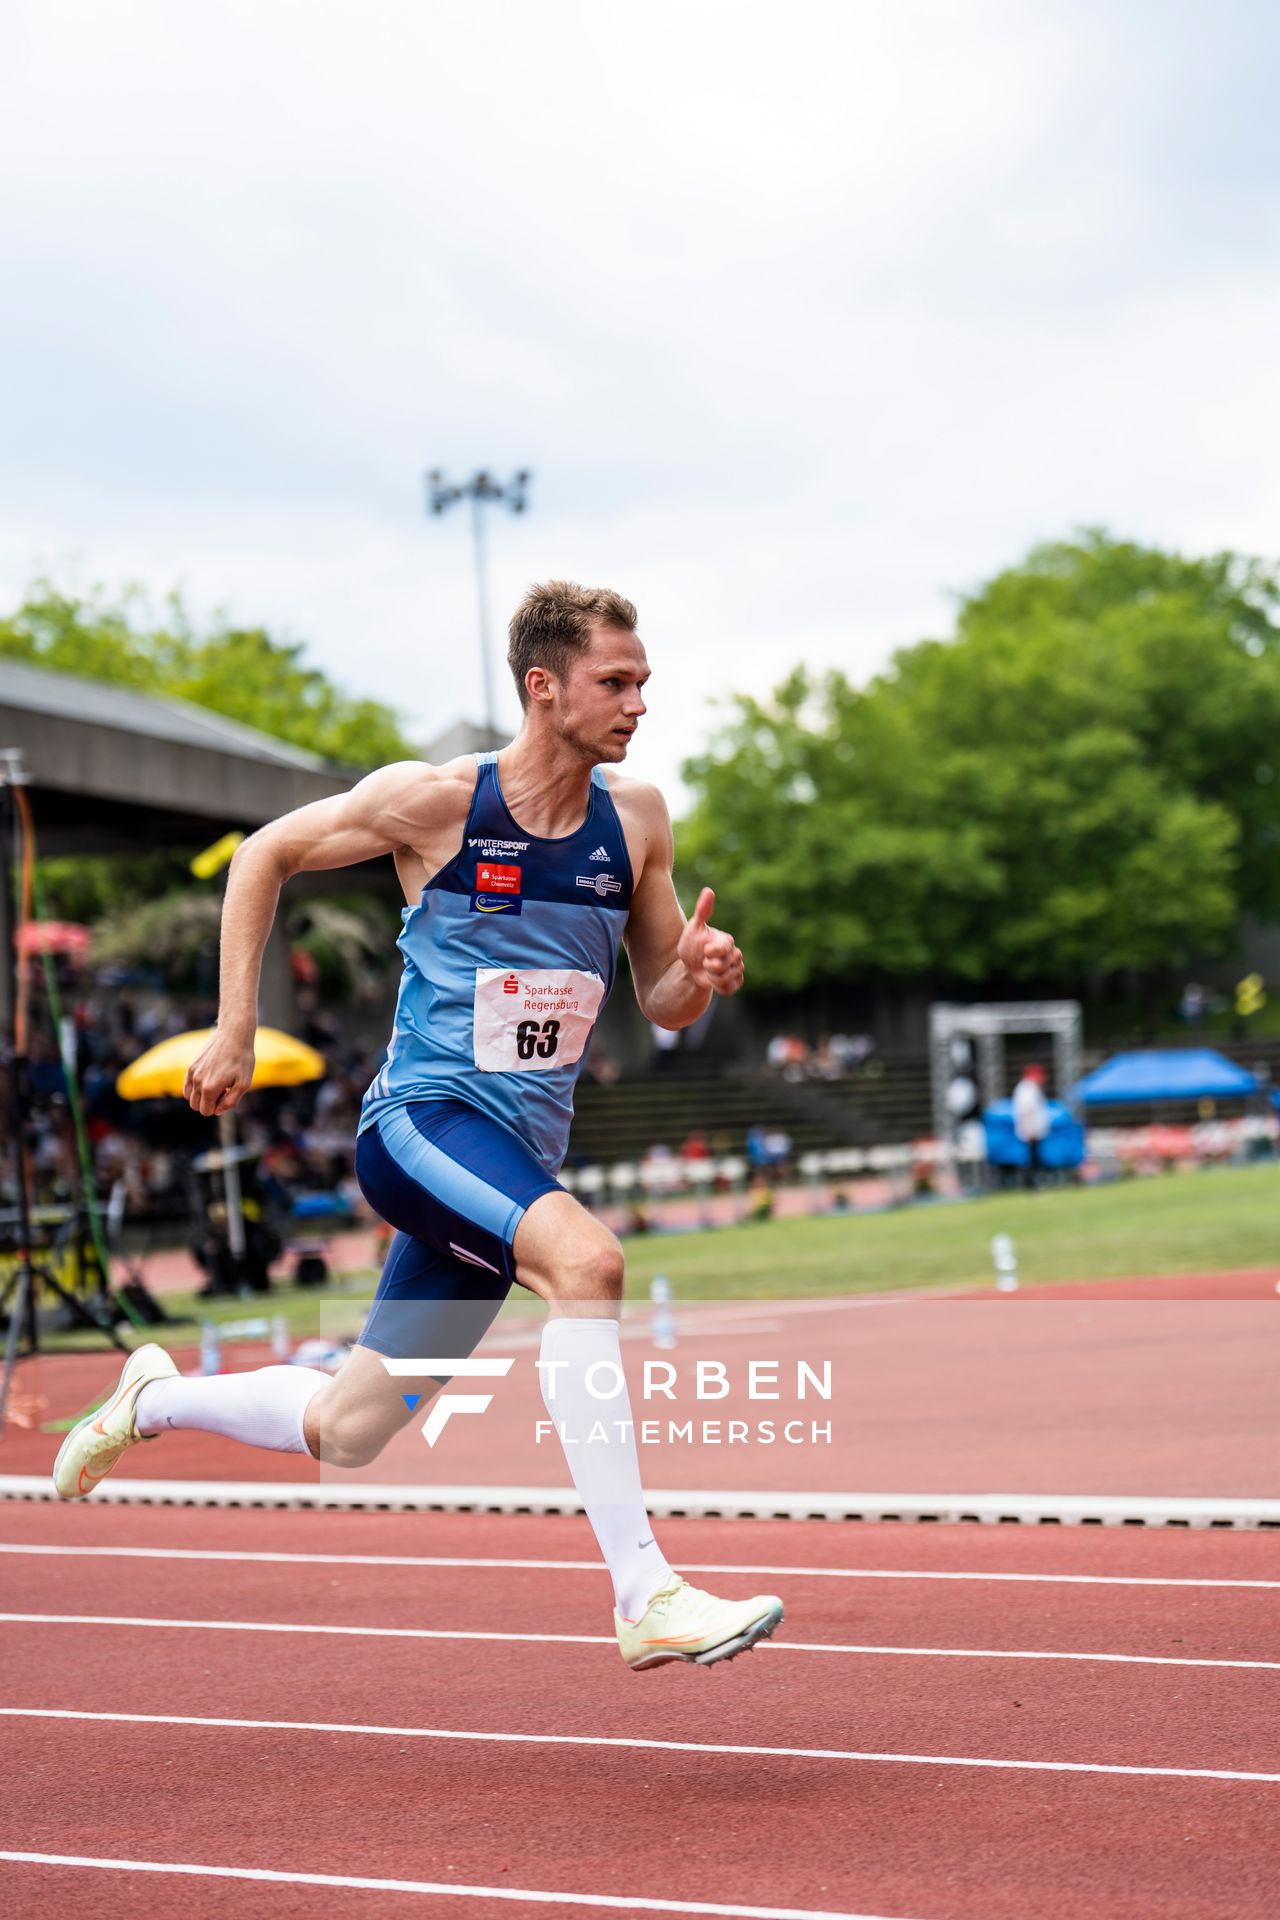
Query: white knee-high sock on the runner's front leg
[{"left": 537, "top": 1317, "right": 672, "bottom": 1620}]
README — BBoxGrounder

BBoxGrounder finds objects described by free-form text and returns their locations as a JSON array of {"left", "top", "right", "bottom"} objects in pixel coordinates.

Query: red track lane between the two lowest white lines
[{"left": 0, "top": 1712, "right": 1280, "bottom": 1920}]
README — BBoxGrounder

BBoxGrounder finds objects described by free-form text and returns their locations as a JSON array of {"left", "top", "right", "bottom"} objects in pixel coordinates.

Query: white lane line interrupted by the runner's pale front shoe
[{"left": 0, "top": 1613, "right": 1280, "bottom": 1672}]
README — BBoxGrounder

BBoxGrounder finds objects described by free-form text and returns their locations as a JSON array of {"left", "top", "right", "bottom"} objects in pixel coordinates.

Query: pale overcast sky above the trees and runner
[{"left": 0, "top": 0, "right": 1280, "bottom": 783}]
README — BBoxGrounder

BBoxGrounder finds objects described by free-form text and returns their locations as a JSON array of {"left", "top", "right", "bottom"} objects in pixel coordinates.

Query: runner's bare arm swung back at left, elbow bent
[{"left": 182, "top": 760, "right": 427, "bottom": 1116}]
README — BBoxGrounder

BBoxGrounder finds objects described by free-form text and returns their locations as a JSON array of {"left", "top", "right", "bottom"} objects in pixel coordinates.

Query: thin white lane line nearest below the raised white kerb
[{"left": 0, "top": 1540, "right": 1280, "bottom": 1590}]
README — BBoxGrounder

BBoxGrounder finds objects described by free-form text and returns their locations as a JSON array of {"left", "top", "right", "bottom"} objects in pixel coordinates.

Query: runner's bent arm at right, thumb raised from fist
[{"left": 626, "top": 787, "right": 743, "bottom": 1027}]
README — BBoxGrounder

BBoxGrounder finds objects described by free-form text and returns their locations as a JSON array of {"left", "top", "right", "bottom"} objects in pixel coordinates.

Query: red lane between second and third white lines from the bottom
[{"left": 0, "top": 1624, "right": 1280, "bottom": 1774}]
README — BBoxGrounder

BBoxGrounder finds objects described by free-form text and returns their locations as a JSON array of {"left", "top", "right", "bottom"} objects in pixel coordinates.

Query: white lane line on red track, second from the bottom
[{"left": 0, "top": 1707, "right": 1280, "bottom": 1786}]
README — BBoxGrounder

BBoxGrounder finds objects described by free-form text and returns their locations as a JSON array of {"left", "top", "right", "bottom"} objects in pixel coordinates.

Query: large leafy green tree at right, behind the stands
[{"left": 683, "top": 532, "right": 1280, "bottom": 989}]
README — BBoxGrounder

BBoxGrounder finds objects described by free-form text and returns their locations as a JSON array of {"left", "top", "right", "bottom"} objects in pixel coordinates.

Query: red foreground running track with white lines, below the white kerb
[{"left": 0, "top": 1503, "right": 1280, "bottom": 1920}]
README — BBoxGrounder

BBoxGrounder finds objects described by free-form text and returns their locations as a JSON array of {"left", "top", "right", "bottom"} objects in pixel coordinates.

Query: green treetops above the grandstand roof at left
[{"left": 0, "top": 582, "right": 415, "bottom": 772}]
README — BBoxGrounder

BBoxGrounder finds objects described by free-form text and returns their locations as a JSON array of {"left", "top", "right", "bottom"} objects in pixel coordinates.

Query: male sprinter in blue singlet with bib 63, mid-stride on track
[{"left": 54, "top": 580, "right": 783, "bottom": 1668}]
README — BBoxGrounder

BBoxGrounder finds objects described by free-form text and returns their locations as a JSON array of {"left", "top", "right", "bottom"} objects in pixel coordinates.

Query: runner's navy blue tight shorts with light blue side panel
[{"left": 355, "top": 1100, "right": 564, "bottom": 1359}]
